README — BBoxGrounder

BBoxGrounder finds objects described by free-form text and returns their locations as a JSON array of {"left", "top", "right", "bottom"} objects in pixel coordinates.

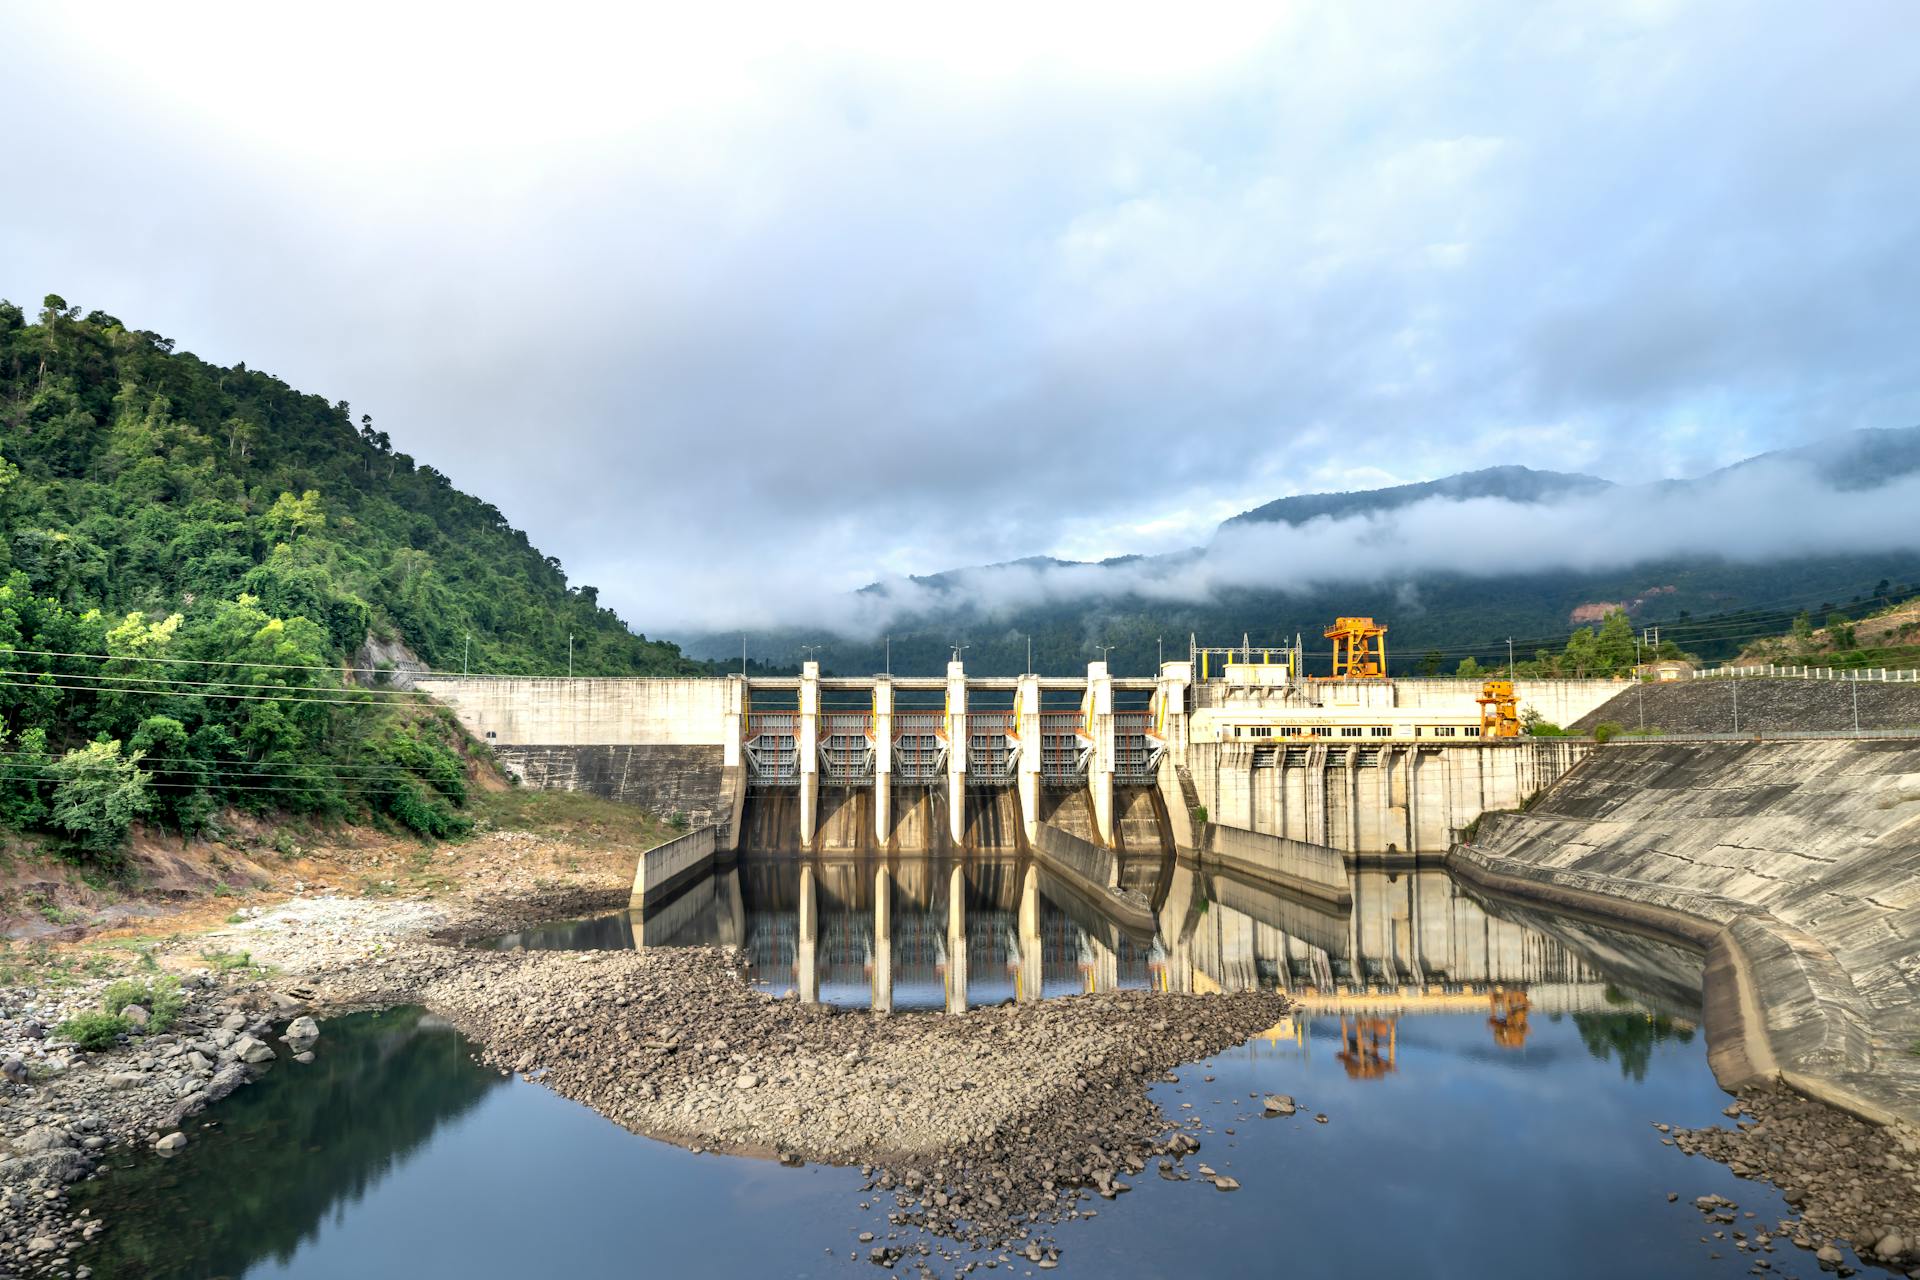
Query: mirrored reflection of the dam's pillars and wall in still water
[{"left": 503, "top": 854, "right": 1697, "bottom": 1038}]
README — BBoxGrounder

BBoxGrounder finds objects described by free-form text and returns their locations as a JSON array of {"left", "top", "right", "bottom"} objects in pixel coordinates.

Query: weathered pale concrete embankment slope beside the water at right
[{"left": 1450, "top": 739, "right": 1920, "bottom": 1123}]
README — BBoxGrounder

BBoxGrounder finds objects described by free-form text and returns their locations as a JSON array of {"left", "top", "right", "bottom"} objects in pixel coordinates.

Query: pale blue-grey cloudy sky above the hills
[{"left": 0, "top": 0, "right": 1920, "bottom": 633}]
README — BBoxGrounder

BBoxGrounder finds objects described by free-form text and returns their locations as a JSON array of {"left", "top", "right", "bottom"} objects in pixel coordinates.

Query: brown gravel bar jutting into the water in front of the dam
[{"left": 407, "top": 950, "right": 1288, "bottom": 1263}]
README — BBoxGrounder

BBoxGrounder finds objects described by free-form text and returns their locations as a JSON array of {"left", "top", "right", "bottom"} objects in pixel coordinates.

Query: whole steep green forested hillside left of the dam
[{"left": 0, "top": 289, "right": 701, "bottom": 858}]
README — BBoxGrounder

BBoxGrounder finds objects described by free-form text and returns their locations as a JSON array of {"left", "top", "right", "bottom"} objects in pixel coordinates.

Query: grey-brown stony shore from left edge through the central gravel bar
[{"left": 0, "top": 890, "right": 1288, "bottom": 1276}]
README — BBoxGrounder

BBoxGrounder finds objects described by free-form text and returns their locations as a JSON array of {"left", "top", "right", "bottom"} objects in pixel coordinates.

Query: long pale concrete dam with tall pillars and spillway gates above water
[{"left": 417, "top": 662, "right": 1624, "bottom": 854}]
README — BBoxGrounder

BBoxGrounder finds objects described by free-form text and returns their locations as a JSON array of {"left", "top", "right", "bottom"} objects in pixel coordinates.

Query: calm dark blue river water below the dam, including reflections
[{"left": 79, "top": 860, "right": 1814, "bottom": 1278}]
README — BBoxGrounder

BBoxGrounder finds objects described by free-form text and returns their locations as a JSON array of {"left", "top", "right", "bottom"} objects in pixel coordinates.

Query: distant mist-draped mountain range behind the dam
[{"left": 684, "top": 428, "right": 1920, "bottom": 674}]
